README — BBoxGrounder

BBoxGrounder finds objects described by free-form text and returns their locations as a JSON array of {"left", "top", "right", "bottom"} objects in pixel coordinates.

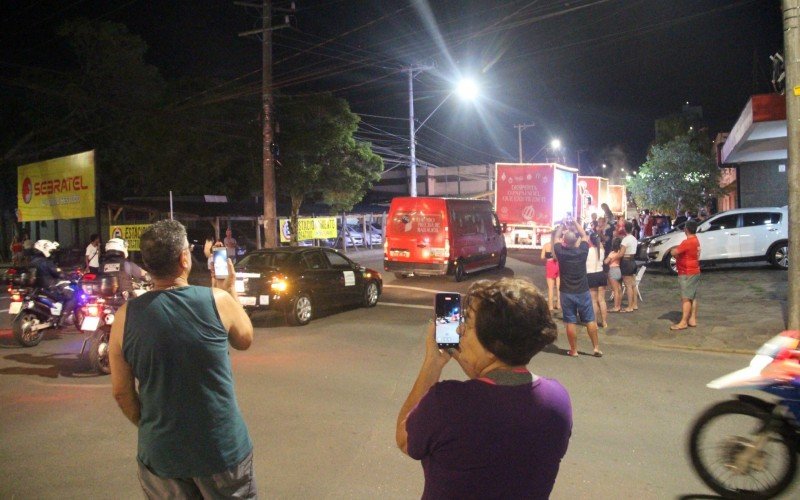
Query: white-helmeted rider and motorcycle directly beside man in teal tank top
[{"left": 79, "top": 238, "right": 152, "bottom": 374}]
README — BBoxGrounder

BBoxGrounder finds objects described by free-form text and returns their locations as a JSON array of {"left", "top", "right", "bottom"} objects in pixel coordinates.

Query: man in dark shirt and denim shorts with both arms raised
[{"left": 553, "top": 217, "right": 603, "bottom": 357}]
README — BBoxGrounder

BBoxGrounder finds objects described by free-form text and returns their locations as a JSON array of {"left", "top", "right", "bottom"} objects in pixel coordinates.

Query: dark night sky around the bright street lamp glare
[{"left": 0, "top": 0, "right": 783, "bottom": 173}]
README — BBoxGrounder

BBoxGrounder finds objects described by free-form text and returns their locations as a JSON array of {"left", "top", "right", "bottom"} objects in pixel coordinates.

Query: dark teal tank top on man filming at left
[{"left": 122, "top": 286, "right": 253, "bottom": 478}]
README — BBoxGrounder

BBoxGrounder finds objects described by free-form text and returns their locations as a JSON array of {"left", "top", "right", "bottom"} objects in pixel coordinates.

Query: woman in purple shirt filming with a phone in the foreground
[{"left": 395, "top": 278, "right": 572, "bottom": 499}]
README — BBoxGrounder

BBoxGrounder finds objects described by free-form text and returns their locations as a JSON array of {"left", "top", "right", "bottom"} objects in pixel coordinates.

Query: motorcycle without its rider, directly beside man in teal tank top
[{"left": 79, "top": 280, "right": 152, "bottom": 375}]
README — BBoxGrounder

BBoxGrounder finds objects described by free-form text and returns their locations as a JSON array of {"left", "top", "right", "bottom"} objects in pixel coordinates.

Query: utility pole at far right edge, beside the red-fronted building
[{"left": 781, "top": 0, "right": 800, "bottom": 330}]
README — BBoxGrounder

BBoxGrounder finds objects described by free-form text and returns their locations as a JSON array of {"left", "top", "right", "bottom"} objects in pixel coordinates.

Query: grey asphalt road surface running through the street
[{"left": 0, "top": 252, "right": 800, "bottom": 499}]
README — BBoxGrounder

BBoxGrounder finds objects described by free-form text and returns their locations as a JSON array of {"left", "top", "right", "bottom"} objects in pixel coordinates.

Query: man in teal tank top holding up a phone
[{"left": 109, "top": 220, "right": 258, "bottom": 498}]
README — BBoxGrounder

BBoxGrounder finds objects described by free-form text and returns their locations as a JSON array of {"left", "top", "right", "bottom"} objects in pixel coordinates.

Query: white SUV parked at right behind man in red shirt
[{"left": 647, "top": 207, "right": 789, "bottom": 273}]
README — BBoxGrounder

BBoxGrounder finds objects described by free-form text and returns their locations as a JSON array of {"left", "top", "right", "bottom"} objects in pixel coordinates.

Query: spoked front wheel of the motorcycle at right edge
[{"left": 689, "top": 400, "right": 797, "bottom": 498}]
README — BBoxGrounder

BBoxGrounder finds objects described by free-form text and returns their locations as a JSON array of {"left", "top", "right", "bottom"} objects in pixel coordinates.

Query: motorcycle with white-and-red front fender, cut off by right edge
[{"left": 689, "top": 331, "right": 800, "bottom": 498}]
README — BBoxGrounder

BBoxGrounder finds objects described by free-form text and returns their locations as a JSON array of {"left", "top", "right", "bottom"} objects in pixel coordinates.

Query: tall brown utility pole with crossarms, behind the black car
[{"left": 234, "top": 0, "right": 295, "bottom": 247}]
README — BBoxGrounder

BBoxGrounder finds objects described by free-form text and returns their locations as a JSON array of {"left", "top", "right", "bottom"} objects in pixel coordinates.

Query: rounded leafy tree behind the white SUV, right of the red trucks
[{"left": 628, "top": 135, "right": 720, "bottom": 212}]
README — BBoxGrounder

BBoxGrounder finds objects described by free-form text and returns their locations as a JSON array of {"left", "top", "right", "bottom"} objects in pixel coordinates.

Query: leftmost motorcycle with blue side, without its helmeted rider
[{"left": 9, "top": 271, "right": 88, "bottom": 347}]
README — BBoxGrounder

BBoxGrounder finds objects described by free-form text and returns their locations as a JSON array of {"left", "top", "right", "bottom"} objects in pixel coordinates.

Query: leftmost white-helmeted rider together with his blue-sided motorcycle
[{"left": 9, "top": 240, "right": 88, "bottom": 347}]
